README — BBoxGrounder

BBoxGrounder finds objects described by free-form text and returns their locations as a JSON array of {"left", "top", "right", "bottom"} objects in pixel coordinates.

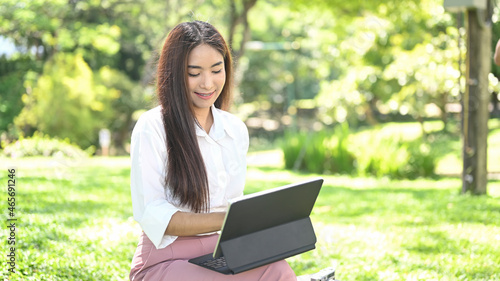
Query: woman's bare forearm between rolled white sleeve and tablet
[{"left": 165, "top": 212, "right": 226, "bottom": 236}]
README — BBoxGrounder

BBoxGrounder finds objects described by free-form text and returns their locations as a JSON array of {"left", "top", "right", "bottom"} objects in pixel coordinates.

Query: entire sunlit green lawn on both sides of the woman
[{"left": 0, "top": 152, "right": 500, "bottom": 280}]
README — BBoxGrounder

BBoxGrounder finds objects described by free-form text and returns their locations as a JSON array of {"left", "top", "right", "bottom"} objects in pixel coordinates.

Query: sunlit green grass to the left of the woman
[{"left": 0, "top": 158, "right": 139, "bottom": 280}]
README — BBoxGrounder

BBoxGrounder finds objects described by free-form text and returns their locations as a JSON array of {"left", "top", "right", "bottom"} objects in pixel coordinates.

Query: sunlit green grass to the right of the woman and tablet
[{"left": 249, "top": 167, "right": 500, "bottom": 280}]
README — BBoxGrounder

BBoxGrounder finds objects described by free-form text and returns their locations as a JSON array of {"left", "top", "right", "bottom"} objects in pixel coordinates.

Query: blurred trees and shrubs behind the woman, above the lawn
[{"left": 0, "top": 0, "right": 500, "bottom": 177}]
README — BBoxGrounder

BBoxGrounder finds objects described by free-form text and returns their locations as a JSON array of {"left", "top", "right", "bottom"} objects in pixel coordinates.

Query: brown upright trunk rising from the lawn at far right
[{"left": 462, "top": 3, "right": 491, "bottom": 194}]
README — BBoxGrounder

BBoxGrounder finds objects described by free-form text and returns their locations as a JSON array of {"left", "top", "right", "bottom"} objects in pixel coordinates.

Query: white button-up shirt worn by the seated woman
[{"left": 130, "top": 106, "right": 249, "bottom": 249}]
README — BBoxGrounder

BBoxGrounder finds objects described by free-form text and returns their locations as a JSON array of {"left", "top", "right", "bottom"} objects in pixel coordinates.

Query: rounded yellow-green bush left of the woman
[{"left": 16, "top": 53, "right": 119, "bottom": 148}]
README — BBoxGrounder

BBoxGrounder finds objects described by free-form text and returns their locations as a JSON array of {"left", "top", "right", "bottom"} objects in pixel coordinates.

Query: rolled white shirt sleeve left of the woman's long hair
[{"left": 130, "top": 112, "right": 179, "bottom": 249}]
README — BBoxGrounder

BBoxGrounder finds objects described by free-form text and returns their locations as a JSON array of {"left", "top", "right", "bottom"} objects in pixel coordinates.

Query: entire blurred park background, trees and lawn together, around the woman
[{"left": 0, "top": 0, "right": 500, "bottom": 281}]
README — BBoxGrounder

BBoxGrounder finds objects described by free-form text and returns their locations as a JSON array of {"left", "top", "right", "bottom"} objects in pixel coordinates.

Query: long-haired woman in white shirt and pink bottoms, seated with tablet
[{"left": 130, "top": 21, "right": 296, "bottom": 281}]
